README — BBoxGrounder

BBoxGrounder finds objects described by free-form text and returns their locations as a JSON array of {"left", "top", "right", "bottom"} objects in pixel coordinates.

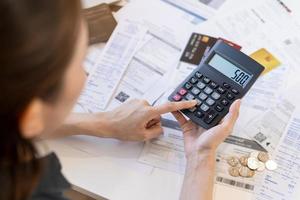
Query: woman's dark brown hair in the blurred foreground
[{"left": 0, "top": 0, "right": 81, "bottom": 200}]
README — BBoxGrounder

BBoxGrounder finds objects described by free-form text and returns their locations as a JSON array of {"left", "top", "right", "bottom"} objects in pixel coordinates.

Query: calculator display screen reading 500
[{"left": 208, "top": 53, "right": 253, "bottom": 87}]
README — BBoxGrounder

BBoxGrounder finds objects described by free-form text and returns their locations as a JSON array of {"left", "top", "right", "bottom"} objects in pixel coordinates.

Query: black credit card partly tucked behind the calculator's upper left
[{"left": 180, "top": 33, "right": 217, "bottom": 65}]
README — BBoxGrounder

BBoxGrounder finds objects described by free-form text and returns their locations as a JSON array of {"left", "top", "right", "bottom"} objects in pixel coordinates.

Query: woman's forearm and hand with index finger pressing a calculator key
[{"left": 57, "top": 100, "right": 197, "bottom": 141}]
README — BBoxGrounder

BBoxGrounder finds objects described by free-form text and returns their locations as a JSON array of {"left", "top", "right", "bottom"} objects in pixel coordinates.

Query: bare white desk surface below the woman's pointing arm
[{"left": 47, "top": 136, "right": 251, "bottom": 200}]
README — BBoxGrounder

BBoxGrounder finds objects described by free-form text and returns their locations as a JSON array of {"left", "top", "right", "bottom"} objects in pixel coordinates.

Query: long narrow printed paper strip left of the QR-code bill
[{"left": 78, "top": 21, "right": 147, "bottom": 112}]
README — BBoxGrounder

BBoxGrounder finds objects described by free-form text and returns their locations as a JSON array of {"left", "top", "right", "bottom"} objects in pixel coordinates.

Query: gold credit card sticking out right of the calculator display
[{"left": 250, "top": 48, "right": 281, "bottom": 74}]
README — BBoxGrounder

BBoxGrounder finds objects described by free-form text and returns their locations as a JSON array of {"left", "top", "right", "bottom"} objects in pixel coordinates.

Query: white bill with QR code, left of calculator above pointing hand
[{"left": 108, "top": 22, "right": 182, "bottom": 110}]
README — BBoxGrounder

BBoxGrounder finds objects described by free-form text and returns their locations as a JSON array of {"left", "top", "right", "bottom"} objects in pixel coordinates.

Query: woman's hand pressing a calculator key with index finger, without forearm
[{"left": 106, "top": 100, "right": 197, "bottom": 141}]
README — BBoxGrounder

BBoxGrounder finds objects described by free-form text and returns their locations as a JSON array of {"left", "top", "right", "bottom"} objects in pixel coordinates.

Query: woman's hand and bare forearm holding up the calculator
[{"left": 173, "top": 100, "right": 240, "bottom": 200}]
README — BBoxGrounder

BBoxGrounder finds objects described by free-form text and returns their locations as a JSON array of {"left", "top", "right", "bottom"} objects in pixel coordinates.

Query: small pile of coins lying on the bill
[{"left": 226, "top": 151, "right": 277, "bottom": 178}]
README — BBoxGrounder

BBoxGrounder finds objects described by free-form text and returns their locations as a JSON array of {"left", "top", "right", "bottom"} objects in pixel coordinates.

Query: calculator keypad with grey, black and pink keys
[{"left": 172, "top": 71, "right": 239, "bottom": 124}]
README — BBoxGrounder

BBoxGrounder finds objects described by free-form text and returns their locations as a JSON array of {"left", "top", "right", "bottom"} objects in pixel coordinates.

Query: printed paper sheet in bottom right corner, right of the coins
[{"left": 254, "top": 113, "right": 300, "bottom": 200}]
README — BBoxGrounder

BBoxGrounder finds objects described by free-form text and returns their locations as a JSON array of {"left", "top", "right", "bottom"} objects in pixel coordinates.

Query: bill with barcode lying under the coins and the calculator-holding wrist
[{"left": 139, "top": 119, "right": 265, "bottom": 193}]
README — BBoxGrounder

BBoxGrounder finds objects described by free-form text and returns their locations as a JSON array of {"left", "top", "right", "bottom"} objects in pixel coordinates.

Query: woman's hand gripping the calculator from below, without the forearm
[{"left": 172, "top": 100, "right": 241, "bottom": 158}]
